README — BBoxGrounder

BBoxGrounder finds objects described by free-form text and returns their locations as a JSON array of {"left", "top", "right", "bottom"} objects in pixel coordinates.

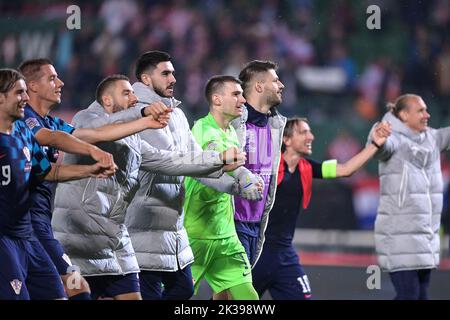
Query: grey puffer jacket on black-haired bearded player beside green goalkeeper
[{"left": 125, "top": 82, "right": 234, "bottom": 272}]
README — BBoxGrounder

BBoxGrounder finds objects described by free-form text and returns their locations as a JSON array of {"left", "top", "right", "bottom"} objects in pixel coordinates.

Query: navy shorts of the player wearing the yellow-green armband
[{"left": 252, "top": 246, "right": 312, "bottom": 300}]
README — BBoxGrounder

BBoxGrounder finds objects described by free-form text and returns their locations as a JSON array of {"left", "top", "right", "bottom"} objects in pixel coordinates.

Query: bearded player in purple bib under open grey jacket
[{"left": 232, "top": 60, "right": 286, "bottom": 266}]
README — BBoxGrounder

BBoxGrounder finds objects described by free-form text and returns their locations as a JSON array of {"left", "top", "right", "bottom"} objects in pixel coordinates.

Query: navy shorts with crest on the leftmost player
[{"left": 0, "top": 235, "right": 67, "bottom": 300}]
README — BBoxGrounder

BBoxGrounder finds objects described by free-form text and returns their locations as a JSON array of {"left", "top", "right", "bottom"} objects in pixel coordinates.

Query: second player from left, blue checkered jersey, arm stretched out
[{"left": 19, "top": 59, "right": 171, "bottom": 300}]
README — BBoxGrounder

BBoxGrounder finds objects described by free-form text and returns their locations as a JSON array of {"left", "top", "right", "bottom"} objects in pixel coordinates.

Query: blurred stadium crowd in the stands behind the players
[{"left": 0, "top": 0, "right": 450, "bottom": 232}]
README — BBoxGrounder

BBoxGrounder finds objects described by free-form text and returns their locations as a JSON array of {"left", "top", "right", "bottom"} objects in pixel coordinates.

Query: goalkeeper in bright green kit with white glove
[{"left": 184, "top": 76, "right": 264, "bottom": 300}]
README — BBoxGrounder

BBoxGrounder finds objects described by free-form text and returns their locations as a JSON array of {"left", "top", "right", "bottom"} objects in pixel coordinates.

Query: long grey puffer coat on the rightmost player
[{"left": 369, "top": 112, "right": 450, "bottom": 272}]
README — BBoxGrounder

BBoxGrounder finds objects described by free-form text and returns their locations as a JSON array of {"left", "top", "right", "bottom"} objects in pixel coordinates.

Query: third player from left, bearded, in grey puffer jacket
[{"left": 52, "top": 75, "right": 246, "bottom": 300}]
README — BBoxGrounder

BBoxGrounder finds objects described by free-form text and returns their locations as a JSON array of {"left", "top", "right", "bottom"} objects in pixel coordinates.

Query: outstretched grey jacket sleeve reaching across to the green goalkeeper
[{"left": 141, "top": 140, "right": 223, "bottom": 178}]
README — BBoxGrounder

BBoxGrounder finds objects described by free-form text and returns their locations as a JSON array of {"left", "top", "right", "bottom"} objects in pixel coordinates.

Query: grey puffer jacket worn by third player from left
[{"left": 52, "top": 102, "right": 227, "bottom": 275}]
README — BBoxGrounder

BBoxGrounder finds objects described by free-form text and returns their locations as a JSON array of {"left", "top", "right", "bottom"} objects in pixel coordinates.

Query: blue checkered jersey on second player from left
[{"left": 23, "top": 105, "right": 75, "bottom": 239}]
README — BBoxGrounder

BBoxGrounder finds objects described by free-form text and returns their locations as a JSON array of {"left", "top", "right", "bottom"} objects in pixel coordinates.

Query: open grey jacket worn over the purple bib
[{"left": 231, "top": 106, "right": 287, "bottom": 268}]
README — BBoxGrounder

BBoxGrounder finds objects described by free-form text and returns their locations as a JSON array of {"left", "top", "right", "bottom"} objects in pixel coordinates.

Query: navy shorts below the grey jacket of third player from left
[{"left": 85, "top": 273, "right": 141, "bottom": 300}]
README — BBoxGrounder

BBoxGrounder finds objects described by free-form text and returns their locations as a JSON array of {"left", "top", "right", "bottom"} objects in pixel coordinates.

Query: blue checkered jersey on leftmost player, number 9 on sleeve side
[{"left": 0, "top": 121, "right": 51, "bottom": 238}]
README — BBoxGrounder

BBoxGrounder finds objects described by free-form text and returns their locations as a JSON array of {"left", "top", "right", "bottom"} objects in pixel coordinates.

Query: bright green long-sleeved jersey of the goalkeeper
[{"left": 184, "top": 113, "right": 239, "bottom": 239}]
